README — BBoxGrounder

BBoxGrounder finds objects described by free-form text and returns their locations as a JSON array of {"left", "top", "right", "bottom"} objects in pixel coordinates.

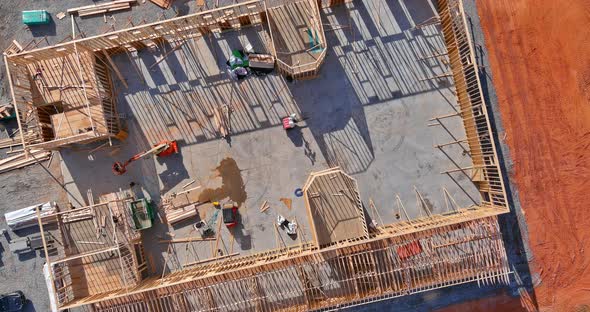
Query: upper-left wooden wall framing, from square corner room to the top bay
[{"left": 4, "top": 0, "right": 326, "bottom": 149}]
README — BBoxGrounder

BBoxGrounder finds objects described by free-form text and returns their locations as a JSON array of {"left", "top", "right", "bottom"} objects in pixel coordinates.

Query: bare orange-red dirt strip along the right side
[{"left": 477, "top": 0, "right": 590, "bottom": 311}]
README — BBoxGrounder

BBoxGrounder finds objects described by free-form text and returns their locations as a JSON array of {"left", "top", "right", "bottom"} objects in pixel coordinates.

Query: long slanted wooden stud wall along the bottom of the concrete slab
[{"left": 70, "top": 216, "right": 510, "bottom": 311}]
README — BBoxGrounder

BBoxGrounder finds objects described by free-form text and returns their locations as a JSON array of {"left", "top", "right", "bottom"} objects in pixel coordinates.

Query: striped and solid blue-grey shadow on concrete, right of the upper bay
[{"left": 290, "top": 1, "right": 452, "bottom": 174}]
